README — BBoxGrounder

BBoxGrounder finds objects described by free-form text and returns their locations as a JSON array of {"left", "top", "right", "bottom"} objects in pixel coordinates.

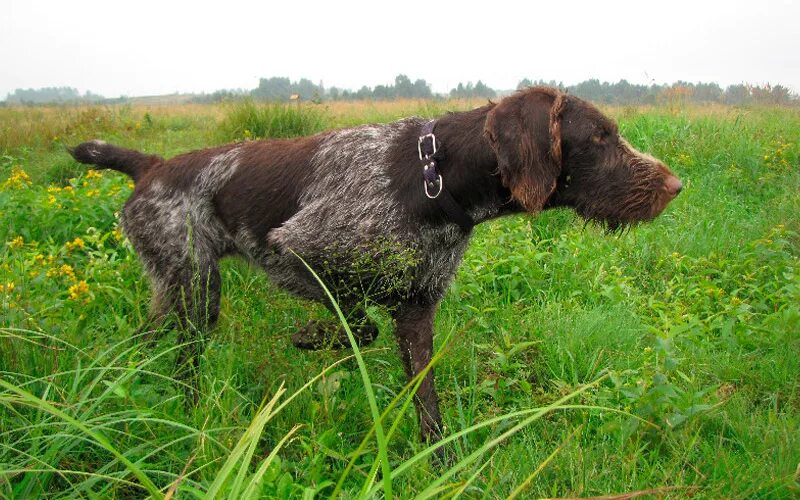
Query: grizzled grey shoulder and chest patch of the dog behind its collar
[{"left": 248, "top": 120, "right": 468, "bottom": 302}]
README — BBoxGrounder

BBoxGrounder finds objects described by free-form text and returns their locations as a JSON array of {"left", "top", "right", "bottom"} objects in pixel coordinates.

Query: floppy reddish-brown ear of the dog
[{"left": 484, "top": 88, "right": 566, "bottom": 213}]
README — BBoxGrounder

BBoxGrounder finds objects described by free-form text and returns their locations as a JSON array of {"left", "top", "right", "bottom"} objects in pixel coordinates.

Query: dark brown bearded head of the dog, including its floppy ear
[{"left": 485, "top": 87, "right": 681, "bottom": 229}]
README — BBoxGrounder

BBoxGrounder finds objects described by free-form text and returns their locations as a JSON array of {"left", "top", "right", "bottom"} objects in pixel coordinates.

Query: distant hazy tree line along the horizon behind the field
[{"left": 6, "top": 74, "right": 798, "bottom": 105}]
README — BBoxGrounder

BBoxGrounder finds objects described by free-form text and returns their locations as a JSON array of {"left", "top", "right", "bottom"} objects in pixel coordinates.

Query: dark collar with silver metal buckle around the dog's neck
[{"left": 417, "top": 120, "right": 475, "bottom": 233}]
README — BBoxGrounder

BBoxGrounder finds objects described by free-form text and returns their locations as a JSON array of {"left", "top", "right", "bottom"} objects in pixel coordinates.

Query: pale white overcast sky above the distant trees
[{"left": 0, "top": 0, "right": 800, "bottom": 99}]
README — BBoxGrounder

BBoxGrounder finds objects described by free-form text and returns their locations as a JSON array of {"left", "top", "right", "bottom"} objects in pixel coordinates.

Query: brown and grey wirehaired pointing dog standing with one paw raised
[{"left": 70, "top": 87, "right": 682, "bottom": 442}]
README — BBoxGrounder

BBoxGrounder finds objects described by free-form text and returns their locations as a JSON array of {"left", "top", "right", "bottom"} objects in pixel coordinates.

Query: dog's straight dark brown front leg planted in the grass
[{"left": 394, "top": 304, "right": 442, "bottom": 443}]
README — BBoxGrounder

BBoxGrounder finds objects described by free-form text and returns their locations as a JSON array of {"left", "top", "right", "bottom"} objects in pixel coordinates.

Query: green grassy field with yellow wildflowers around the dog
[{"left": 0, "top": 97, "right": 800, "bottom": 498}]
